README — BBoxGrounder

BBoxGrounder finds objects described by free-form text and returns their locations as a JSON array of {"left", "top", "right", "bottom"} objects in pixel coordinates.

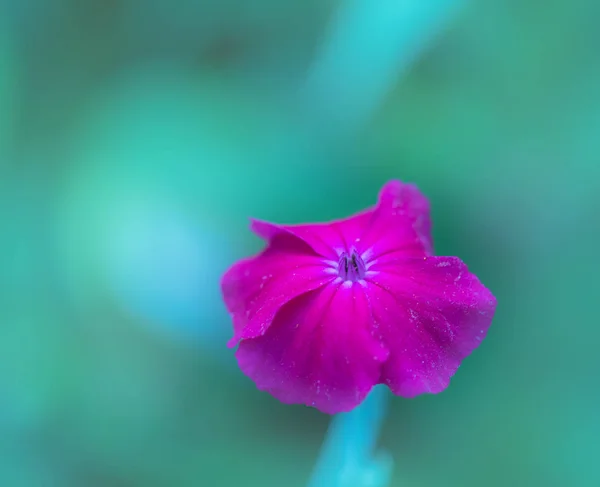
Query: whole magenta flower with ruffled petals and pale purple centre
[{"left": 221, "top": 181, "right": 496, "bottom": 414}]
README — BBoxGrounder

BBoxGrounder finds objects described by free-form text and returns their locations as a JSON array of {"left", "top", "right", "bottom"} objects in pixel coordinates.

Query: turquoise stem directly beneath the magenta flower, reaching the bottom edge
[{"left": 308, "top": 386, "right": 392, "bottom": 487}]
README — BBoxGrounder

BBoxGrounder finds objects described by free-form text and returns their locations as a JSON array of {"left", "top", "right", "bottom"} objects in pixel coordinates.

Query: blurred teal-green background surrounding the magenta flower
[{"left": 0, "top": 0, "right": 600, "bottom": 487}]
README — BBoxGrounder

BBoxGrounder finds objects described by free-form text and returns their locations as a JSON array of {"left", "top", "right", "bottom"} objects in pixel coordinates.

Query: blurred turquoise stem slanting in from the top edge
[{"left": 305, "top": 0, "right": 464, "bottom": 132}]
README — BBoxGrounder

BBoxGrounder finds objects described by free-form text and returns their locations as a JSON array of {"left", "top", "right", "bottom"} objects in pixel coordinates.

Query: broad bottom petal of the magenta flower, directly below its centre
[{"left": 236, "top": 283, "right": 389, "bottom": 414}]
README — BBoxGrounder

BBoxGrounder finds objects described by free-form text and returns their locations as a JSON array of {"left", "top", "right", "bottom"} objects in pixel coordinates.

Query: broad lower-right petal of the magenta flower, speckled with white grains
[{"left": 369, "top": 257, "right": 496, "bottom": 397}]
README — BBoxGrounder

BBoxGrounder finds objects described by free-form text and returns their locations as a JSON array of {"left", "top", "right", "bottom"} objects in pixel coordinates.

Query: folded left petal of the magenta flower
[{"left": 221, "top": 233, "right": 336, "bottom": 347}]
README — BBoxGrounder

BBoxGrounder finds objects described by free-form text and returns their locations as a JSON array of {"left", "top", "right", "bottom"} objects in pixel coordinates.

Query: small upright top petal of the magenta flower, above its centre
[{"left": 361, "top": 181, "right": 433, "bottom": 260}]
